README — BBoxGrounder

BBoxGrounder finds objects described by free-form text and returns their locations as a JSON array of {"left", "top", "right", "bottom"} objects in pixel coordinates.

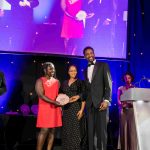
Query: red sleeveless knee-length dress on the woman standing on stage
[{"left": 36, "top": 77, "right": 62, "bottom": 128}]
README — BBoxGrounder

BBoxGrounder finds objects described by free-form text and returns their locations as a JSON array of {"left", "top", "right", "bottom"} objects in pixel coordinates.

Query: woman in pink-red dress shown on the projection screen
[{"left": 61, "top": 0, "right": 84, "bottom": 54}]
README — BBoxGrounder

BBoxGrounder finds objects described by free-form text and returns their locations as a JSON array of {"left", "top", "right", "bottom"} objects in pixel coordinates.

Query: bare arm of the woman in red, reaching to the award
[{"left": 35, "top": 79, "right": 60, "bottom": 106}]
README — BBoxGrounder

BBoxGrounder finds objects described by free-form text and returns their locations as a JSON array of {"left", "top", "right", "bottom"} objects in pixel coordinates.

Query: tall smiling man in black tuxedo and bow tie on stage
[{"left": 83, "top": 47, "right": 112, "bottom": 150}]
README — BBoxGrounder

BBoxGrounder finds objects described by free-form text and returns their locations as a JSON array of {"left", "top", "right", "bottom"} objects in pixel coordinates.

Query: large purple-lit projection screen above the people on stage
[{"left": 0, "top": 0, "right": 128, "bottom": 58}]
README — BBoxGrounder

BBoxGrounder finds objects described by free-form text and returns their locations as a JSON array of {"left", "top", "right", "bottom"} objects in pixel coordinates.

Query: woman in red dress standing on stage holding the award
[{"left": 35, "top": 62, "right": 62, "bottom": 150}]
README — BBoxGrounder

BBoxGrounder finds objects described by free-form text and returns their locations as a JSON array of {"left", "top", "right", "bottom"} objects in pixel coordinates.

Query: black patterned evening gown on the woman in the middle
[{"left": 61, "top": 79, "right": 87, "bottom": 150}]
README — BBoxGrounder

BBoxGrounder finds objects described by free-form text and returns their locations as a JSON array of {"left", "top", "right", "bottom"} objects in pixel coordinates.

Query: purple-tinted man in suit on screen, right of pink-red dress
[{"left": 84, "top": 0, "right": 114, "bottom": 57}]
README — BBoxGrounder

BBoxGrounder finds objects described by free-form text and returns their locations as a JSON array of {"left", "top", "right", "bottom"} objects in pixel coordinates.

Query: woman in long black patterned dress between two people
[{"left": 61, "top": 65, "right": 86, "bottom": 150}]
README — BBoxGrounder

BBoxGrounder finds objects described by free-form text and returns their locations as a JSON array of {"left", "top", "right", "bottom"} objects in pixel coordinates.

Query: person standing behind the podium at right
[{"left": 118, "top": 72, "right": 138, "bottom": 150}]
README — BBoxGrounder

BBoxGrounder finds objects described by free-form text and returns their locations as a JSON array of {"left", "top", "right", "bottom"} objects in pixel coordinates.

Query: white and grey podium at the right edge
[{"left": 121, "top": 88, "right": 150, "bottom": 150}]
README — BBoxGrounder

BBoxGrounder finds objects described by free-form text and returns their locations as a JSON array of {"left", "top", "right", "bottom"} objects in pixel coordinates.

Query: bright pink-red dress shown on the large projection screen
[{"left": 61, "top": 0, "right": 84, "bottom": 38}]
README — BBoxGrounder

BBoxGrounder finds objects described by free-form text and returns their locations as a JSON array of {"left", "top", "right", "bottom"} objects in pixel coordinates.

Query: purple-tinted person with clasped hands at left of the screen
[{"left": 7, "top": 0, "right": 39, "bottom": 51}]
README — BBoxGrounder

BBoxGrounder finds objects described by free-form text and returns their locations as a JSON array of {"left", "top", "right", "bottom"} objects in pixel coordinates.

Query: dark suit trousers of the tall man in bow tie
[{"left": 87, "top": 105, "right": 108, "bottom": 150}]
